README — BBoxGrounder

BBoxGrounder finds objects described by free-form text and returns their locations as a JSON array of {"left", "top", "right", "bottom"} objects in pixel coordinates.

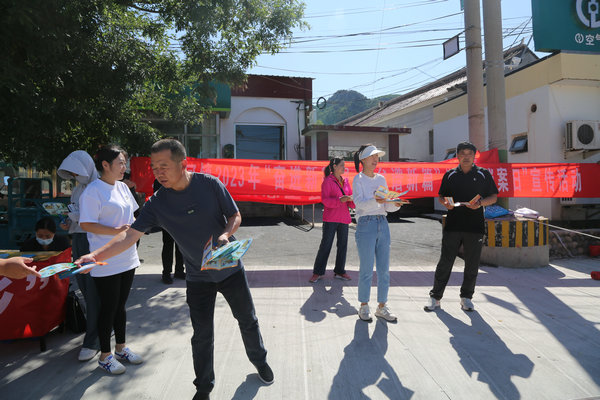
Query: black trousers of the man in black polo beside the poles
[{"left": 429, "top": 231, "right": 483, "bottom": 300}]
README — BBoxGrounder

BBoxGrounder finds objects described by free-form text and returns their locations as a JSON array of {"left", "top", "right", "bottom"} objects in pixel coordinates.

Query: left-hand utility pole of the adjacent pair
[{"left": 464, "top": 0, "right": 486, "bottom": 151}]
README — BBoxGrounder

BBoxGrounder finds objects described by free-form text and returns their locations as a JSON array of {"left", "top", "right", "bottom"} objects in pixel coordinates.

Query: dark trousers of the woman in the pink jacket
[{"left": 313, "top": 222, "right": 348, "bottom": 275}]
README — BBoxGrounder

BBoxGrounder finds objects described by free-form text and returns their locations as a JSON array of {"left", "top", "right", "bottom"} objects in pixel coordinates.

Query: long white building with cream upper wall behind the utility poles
[{"left": 343, "top": 46, "right": 600, "bottom": 219}]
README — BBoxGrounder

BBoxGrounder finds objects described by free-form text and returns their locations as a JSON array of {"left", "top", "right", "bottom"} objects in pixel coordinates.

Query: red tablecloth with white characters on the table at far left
[{"left": 0, "top": 248, "right": 71, "bottom": 340}]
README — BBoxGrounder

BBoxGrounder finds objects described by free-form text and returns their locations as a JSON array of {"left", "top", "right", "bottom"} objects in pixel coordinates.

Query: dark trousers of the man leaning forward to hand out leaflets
[{"left": 186, "top": 269, "right": 267, "bottom": 393}]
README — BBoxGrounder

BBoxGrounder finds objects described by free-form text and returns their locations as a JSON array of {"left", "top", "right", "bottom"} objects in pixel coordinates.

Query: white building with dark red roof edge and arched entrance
[{"left": 150, "top": 75, "right": 312, "bottom": 160}]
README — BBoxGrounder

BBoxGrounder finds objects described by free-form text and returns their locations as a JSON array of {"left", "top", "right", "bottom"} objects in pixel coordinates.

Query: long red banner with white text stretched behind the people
[{"left": 131, "top": 157, "right": 600, "bottom": 205}]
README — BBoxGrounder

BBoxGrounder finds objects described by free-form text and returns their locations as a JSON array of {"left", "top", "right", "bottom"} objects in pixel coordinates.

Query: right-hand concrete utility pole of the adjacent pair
[{"left": 483, "top": 0, "right": 508, "bottom": 162}]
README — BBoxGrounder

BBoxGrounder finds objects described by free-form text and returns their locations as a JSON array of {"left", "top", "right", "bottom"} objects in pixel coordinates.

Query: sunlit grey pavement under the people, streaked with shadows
[{"left": 0, "top": 218, "right": 600, "bottom": 400}]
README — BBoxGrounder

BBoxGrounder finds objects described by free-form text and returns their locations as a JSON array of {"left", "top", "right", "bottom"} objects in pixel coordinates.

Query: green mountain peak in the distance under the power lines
[{"left": 317, "top": 90, "right": 398, "bottom": 125}]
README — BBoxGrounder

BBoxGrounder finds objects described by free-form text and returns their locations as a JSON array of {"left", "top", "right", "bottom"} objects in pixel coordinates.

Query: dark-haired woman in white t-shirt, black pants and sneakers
[{"left": 79, "top": 145, "right": 143, "bottom": 374}]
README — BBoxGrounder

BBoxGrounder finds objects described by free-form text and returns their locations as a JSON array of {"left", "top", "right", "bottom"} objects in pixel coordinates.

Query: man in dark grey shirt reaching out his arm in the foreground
[{"left": 78, "top": 139, "right": 274, "bottom": 399}]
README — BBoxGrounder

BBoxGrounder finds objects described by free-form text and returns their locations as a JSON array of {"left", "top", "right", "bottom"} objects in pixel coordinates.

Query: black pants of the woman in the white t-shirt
[{"left": 94, "top": 268, "right": 135, "bottom": 353}]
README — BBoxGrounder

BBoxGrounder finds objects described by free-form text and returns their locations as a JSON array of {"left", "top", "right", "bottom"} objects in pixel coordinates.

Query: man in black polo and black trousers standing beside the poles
[{"left": 425, "top": 142, "right": 498, "bottom": 311}]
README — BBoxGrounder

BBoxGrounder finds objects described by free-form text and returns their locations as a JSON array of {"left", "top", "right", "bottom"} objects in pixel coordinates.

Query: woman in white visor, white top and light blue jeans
[{"left": 352, "top": 144, "right": 400, "bottom": 322}]
